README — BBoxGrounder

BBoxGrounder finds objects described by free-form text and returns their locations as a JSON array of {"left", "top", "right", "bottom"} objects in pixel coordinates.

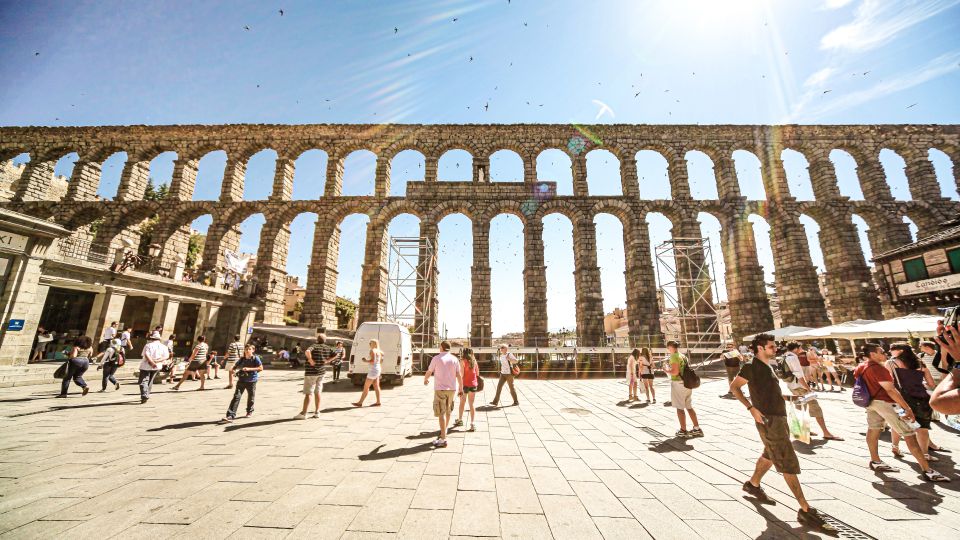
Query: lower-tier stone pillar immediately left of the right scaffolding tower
[{"left": 623, "top": 216, "right": 663, "bottom": 347}]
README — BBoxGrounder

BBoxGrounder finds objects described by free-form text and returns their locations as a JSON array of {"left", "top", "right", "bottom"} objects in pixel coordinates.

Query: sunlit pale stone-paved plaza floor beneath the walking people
[{"left": 0, "top": 371, "right": 960, "bottom": 540}]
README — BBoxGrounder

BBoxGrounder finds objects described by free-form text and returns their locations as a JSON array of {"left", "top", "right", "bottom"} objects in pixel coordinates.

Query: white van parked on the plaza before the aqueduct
[{"left": 347, "top": 322, "right": 413, "bottom": 386}]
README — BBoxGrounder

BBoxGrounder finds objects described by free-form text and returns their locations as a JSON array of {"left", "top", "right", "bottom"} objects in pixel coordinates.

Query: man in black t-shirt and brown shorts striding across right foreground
[{"left": 730, "top": 334, "right": 836, "bottom": 533}]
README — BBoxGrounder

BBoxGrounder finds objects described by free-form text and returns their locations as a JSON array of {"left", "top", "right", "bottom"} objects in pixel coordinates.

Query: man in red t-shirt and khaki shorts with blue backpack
[{"left": 853, "top": 343, "right": 950, "bottom": 482}]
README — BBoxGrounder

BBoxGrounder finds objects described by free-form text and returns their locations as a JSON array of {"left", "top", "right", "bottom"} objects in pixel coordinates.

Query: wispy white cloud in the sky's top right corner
[{"left": 820, "top": 0, "right": 960, "bottom": 51}]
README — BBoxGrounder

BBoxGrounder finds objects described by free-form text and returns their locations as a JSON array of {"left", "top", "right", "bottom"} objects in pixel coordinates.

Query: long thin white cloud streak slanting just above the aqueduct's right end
[{"left": 787, "top": 51, "right": 960, "bottom": 122}]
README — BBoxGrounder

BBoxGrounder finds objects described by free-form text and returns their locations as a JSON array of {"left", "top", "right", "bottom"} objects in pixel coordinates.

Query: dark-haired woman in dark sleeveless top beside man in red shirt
[{"left": 887, "top": 343, "right": 939, "bottom": 461}]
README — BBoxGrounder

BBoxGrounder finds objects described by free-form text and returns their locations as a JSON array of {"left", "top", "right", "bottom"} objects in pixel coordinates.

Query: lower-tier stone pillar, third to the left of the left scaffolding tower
[{"left": 254, "top": 221, "right": 290, "bottom": 324}]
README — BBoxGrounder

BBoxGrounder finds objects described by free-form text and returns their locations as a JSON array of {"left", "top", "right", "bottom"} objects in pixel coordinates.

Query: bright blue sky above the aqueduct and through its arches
[{"left": 0, "top": 0, "right": 960, "bottom": 335}]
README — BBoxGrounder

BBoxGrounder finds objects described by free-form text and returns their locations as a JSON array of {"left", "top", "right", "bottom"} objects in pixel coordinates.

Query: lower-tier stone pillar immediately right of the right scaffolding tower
[{"left": 720, "top": 215, "right": 774, "bottom": 343}]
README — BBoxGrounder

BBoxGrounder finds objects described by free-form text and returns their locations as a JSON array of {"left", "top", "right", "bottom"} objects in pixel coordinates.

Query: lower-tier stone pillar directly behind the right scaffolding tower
[{"left": 672, "top": 216, "right": 720, "bottom": 346}]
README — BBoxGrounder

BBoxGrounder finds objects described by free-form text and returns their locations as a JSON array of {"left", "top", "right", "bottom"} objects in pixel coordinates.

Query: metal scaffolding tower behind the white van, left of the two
[{"left": 387, "top": 236, "right": 437, "bottom": 347}]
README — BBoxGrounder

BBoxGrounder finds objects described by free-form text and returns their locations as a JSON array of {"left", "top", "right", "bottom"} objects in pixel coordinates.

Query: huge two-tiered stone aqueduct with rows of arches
[{"left": 0, "top": 125, "right": 960, "bottom": 345}]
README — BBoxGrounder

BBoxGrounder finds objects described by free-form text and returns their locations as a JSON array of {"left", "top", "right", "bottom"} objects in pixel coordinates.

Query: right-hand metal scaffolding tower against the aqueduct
[{"left": 655, "top": 238, "right": 720, "bottom": 352}]
